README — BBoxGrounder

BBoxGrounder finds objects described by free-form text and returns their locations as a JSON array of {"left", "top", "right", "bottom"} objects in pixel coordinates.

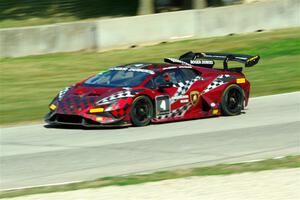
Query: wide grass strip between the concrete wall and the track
[{"left": 0, "top": 28, "right": 300, "bottom": 124}]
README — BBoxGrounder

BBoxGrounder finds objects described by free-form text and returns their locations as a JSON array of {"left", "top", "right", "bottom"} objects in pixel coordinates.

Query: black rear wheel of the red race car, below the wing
[{"left": 221, "top": 84, "right": 244, "bottom": 116}]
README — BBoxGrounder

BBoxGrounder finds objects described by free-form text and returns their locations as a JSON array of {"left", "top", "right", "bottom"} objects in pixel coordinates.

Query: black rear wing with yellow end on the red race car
[{"left": 179, "top": 51, "right": 260, "bottom": 70}]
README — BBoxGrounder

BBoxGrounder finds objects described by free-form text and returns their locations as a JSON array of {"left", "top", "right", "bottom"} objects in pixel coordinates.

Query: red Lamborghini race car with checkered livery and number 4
[{"left": 45, "top": 52, "right": 260, "bottom": 127}]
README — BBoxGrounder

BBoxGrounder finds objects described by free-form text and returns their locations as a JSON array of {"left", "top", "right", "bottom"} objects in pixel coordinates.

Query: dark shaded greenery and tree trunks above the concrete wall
[{"left": 0, "top": 0, "right": 247, "bottom": 28}]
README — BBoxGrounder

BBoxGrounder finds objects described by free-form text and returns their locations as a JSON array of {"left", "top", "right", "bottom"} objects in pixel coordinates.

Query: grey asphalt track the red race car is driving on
[{"left": 0, "top": 92, "right": 300, "bottom": 190}]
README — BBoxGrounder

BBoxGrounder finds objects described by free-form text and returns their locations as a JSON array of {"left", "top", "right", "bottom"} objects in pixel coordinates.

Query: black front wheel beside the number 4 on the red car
[{"left": 130, "top": 96, "right": 153, "bottom": 126}]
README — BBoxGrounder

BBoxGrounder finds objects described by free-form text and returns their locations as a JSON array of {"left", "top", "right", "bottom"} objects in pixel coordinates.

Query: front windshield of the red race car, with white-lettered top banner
[{"left": 83, "top": 67, "right": 154, "bottom": 87}]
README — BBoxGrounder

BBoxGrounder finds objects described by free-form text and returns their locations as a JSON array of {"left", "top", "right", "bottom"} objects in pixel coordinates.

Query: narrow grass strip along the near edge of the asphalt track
[{"left": 0, "top": 156, "right": 300, "bottom": 198}]
